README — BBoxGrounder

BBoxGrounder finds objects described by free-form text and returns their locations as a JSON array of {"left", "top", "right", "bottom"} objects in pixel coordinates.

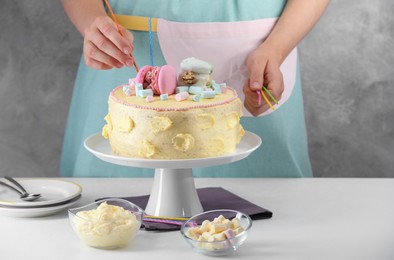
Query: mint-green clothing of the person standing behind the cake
[{"left": 60, "top": 0, "right": 312, "bottom": 177}]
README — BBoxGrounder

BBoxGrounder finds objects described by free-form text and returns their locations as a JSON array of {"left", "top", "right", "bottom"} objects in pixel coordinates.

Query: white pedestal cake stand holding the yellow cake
[{"left": 85, "top": 132, "right": 261, "bottom": 217}]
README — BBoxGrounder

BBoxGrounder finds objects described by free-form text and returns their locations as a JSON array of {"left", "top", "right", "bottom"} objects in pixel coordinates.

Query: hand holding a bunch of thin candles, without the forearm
[{"left": 243, "top": 44, "right": 284, "bottom": 116}]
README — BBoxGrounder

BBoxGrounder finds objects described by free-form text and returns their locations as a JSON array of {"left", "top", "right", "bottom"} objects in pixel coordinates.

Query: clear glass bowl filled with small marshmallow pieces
[{"left": 181, "top": 209, "right": 252, "bottom": 256}]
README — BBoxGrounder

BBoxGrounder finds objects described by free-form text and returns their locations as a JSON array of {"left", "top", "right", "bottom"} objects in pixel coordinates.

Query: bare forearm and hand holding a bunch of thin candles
[{"left": 243, "top": 0, "right": 329, "bottom": 116}]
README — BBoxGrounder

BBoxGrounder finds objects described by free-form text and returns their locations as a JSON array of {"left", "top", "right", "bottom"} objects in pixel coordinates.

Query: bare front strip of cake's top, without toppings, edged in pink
[{"left": 109, "top": 85, "right": 238, "bottom": 111}]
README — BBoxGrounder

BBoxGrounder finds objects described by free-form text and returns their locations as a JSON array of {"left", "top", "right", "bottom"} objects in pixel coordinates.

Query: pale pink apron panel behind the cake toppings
[{"left": 157, "top": 18, "right": 297, "bottom": 116}]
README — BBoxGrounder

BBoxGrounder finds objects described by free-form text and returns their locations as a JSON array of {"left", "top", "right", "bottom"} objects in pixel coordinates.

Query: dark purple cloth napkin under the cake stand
[{"left": 97, "top": 187, "right": 272, "bottom": 231}]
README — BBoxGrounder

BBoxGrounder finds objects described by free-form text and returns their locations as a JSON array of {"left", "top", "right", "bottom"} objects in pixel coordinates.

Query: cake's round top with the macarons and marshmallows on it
[{"left": 110, "top": 57, "right": 242, "bottom": 111}]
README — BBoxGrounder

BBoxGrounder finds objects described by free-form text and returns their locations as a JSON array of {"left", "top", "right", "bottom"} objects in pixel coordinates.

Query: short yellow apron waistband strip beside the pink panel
[{"left": 115, "top": 14, "right": 157, "bottom": 32}]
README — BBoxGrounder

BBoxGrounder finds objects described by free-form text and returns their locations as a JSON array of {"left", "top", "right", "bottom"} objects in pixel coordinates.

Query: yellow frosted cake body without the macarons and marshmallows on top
[{"left": 103, "top": 87, "right": 244, "bottom": 159}]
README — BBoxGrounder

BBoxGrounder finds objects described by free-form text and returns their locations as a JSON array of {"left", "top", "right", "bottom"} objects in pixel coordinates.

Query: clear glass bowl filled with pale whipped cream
[{"left": 68, "top": 199, "right": 144, "bottom": 249}]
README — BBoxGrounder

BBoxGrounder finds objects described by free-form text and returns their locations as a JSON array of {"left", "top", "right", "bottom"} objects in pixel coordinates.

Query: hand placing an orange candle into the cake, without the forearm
[{"left": 83, "top": 15, "right": 134, "bottom": 70}]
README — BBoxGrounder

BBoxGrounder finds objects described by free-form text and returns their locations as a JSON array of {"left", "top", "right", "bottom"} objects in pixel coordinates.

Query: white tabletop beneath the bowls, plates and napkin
[{"left": 0, "top": 178, "right": 394, "bottom": 260}]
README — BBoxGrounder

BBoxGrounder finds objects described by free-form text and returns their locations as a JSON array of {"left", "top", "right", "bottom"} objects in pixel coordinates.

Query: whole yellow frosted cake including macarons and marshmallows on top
[{"left": 102, "top": 57, "right": 244, "bottom": 159}]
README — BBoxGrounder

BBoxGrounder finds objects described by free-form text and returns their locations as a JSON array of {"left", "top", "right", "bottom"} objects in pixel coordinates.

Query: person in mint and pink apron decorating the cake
[{"left": 60, "top": 0, "right": 328, "bottom": 177}]
